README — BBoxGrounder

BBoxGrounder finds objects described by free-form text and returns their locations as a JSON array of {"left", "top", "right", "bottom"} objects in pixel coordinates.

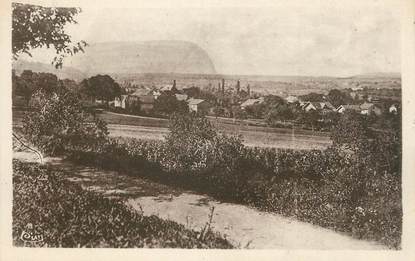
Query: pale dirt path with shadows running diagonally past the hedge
[{"left": 14, "top": 149, "right": 387, "bottom": 250}]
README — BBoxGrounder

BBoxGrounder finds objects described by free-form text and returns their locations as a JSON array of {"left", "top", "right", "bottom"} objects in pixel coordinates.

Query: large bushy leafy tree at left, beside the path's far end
[{"left": 23, "top": 90, "right": 108, "bottom": 155}]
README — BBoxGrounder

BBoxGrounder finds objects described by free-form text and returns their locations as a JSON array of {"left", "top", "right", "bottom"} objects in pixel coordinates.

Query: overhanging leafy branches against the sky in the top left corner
[{"left": 12, "top": 3, "right": 87, "bottom": 68}]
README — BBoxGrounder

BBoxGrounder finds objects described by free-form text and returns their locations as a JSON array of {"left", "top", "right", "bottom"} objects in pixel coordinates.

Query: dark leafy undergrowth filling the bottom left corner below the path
[{"left": 13, "top": 158, "right": 232, "bottom": 248}]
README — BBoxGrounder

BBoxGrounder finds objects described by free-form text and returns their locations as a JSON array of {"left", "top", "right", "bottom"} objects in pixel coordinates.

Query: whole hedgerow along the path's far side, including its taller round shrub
[{"left": 67, "top": 112, "right": 402, "bottom": 248}]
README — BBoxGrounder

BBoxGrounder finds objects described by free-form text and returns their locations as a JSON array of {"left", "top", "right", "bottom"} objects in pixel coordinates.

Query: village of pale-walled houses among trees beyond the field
[{"left": 106, "top": 79, "right": 400, "bottom": 122}]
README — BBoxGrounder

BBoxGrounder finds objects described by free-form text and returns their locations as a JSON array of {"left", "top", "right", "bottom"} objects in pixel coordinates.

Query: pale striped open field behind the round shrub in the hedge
[{"left": 100, "top": 112, "right": 331, "bottom": 149}]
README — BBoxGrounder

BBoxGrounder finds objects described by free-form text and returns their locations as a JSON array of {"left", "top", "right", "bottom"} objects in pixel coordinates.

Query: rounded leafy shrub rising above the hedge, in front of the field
[{"left": 165, "top": 114, "right": 243, "bottom": 172}]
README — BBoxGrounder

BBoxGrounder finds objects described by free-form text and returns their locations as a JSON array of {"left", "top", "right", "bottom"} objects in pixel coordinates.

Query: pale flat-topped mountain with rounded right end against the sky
[{"left": 66, "top": 41, "right": 216, "bottom": 76}]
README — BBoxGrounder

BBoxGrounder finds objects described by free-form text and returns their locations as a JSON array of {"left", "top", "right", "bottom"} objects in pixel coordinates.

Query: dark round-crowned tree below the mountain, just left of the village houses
[{"left": 81, "top": 74, "right": 123, "bottom": 102}]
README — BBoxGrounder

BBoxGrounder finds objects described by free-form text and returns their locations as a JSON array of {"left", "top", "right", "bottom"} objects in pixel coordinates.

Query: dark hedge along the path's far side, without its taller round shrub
[{"left": 70, "top": 138, "right": 402, "bottom": 248}]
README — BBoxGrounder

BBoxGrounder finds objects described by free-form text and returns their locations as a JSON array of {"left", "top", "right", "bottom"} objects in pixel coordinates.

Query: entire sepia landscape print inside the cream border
[{"left": 3, "top": 0, "right": 413, "bottom": 255}]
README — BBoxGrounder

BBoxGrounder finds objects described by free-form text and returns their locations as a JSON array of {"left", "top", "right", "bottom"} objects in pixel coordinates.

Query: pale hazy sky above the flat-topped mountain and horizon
[{"left": 21, "top": 0, "right": 400, "bottom": 76}]
